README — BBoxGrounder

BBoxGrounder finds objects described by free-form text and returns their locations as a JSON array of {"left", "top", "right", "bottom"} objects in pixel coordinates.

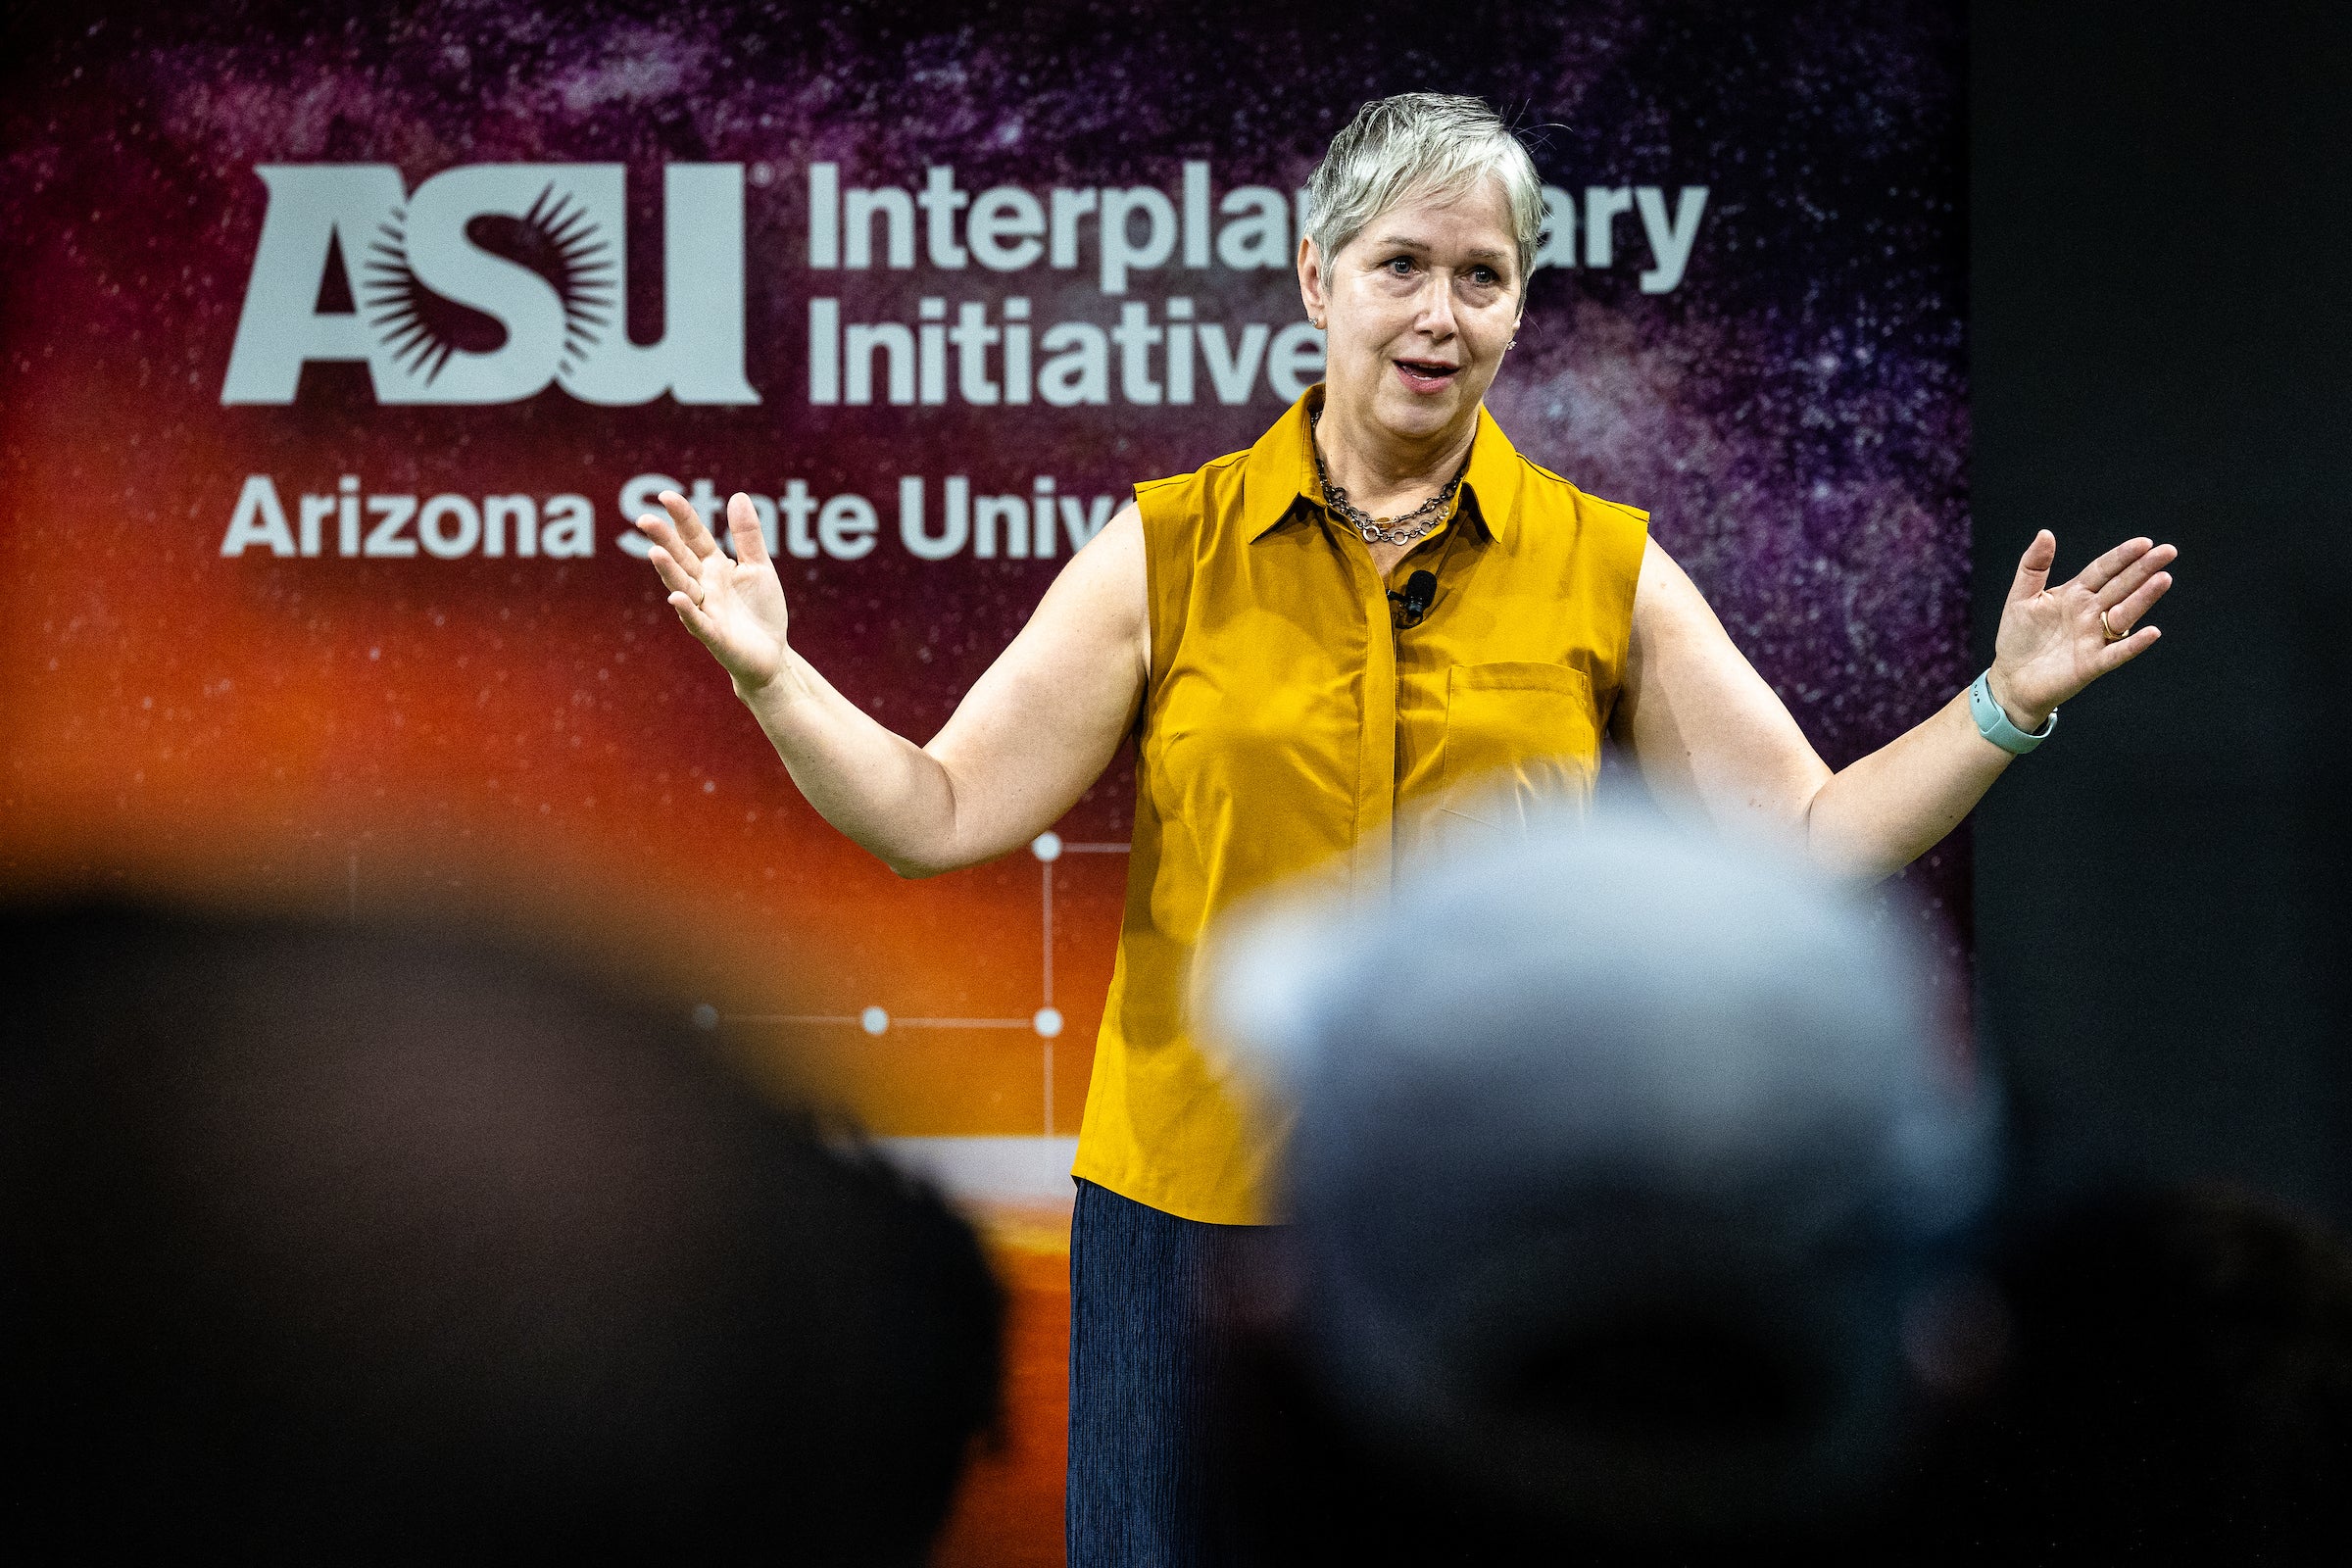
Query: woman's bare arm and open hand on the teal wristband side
[{"left": 1613, "top": 531, "right": 2176, "bottom": 877}]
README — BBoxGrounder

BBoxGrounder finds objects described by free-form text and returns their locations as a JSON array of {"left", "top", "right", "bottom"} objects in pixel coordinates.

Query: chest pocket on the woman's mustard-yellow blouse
[{"left": 1440, "top": 662, "right": 1599, "bottom": 820}]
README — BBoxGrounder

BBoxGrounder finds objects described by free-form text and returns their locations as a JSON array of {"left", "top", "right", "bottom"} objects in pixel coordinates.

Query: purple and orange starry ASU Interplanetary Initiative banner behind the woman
[{"left": 0, "top": 0, "right": 1969, "bottom": 1136}]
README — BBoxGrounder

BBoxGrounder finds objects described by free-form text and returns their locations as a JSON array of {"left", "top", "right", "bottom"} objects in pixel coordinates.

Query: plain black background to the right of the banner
[{"left": 1971, "top": 2, "right": 2352, "bottom": 1220}]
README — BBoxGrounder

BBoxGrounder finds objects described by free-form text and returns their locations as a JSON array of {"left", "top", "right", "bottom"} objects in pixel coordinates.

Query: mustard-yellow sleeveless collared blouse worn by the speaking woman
[{"left": 1075, "top": 385, "right": 1648, "bottom": 1225}]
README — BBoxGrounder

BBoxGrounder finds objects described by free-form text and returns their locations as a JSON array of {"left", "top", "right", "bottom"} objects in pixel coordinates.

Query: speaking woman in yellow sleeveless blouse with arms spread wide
[{"left": 640, "top": 94, "right": 2174, "bottom": 1563}]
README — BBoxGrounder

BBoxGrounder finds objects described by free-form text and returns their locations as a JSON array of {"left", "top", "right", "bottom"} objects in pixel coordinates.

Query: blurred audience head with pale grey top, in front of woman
[{"left": 1206, "top": 820, "right": 1994, "bottom": 1533}]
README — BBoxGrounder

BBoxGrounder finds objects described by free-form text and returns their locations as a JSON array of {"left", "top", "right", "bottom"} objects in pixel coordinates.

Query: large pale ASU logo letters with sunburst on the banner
[{"left": 221, "top": 165, "right": 760, "bottom": 407}]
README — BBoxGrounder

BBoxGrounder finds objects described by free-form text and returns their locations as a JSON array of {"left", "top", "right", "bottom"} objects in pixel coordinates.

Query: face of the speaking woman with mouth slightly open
[{"left": 1298, "top": 178, "right": 1527, "bottom": 442}]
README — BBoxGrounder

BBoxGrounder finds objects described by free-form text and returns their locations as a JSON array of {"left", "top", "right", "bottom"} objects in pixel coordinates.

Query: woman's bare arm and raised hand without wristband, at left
[{"left": 637, "top": 491, "right": 1151, "bottom": 877}]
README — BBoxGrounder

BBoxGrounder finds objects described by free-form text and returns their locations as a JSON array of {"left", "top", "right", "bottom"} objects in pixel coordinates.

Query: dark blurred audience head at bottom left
[{"left": 0, "top": 907, "right": 1002, "bottom": 1563}]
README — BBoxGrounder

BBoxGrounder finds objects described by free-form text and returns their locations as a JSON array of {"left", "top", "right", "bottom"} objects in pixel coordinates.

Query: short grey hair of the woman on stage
[{"left": 1307, "top": 92, "right": 1543, "bottom": 289}]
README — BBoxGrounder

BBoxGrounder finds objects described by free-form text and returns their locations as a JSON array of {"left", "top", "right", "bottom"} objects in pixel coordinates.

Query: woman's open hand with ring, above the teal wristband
[{"left": 1992, "top": 529, "right": 2180, "bottom": 729}]
